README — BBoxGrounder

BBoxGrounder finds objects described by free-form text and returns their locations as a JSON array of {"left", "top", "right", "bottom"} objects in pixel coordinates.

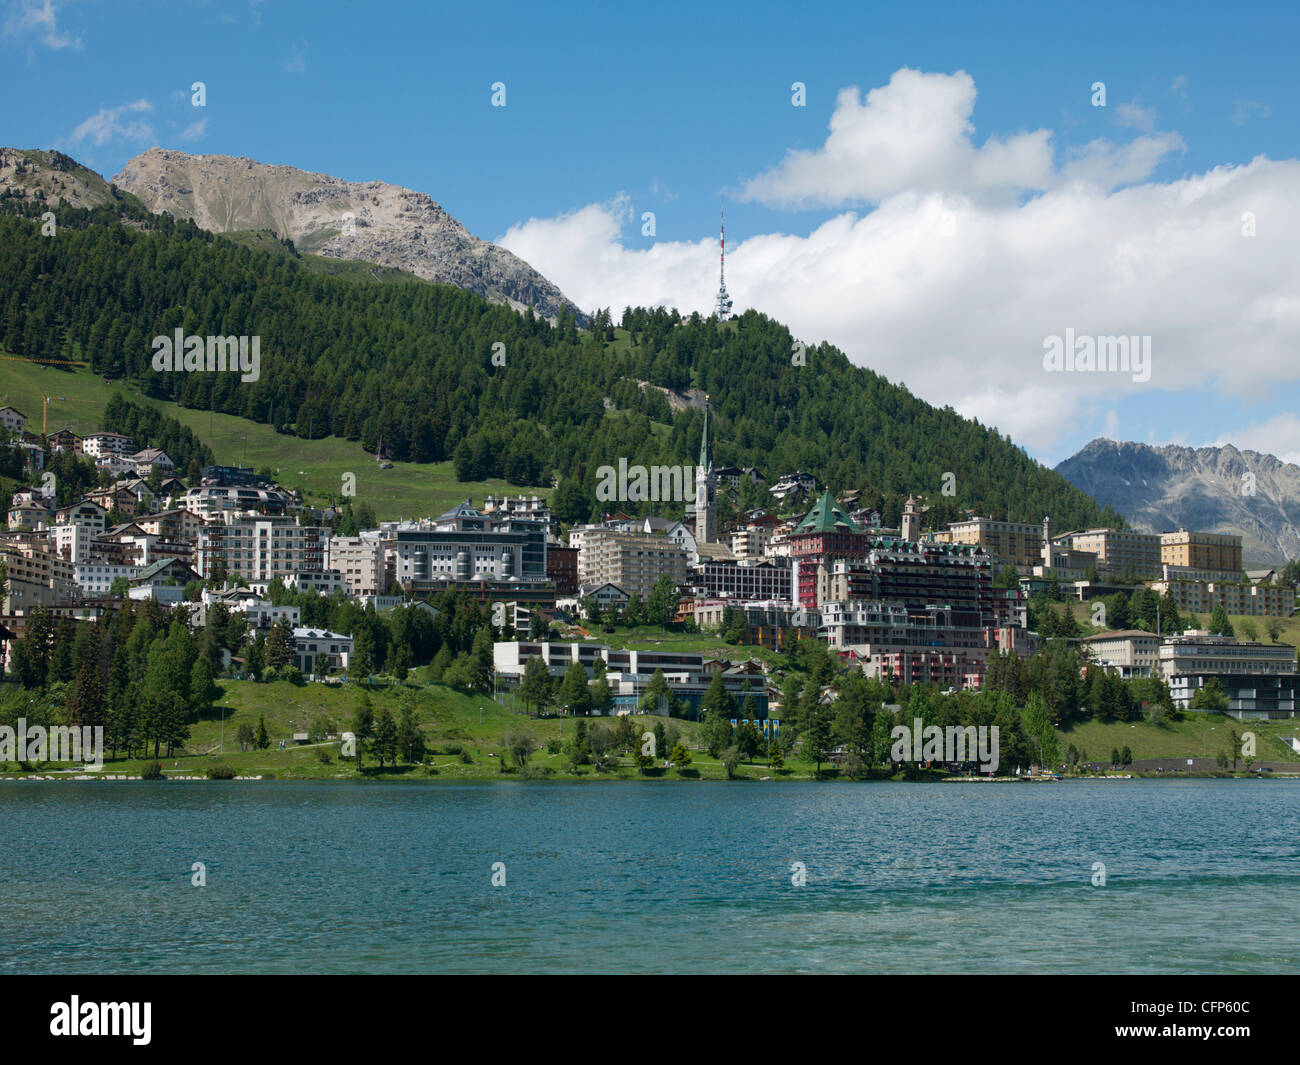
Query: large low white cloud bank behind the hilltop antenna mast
[{"left": 498, "top": 72, "right": 1300, "bottom": 454}]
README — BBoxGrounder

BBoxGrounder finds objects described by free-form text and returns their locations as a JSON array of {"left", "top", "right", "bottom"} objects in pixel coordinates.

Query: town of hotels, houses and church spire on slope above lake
[{"left": 0, "top": 395, "right": 1300, "bottom": 780}]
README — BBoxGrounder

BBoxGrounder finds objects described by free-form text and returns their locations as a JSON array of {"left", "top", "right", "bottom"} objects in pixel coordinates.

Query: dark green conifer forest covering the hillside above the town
[{"left": 0, "top": 191, "right": 1117, "bottom": 528}]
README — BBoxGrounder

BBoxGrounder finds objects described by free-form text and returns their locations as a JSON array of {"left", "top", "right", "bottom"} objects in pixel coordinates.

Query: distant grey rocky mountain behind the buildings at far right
[{"left": 1056, "top": 438, "right": 1300, "bottom": 567}]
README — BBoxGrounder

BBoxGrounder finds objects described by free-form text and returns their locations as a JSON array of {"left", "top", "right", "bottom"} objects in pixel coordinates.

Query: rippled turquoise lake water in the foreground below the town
[{"left": 0, "top": 780, "right": 1300, "bottom": 973}]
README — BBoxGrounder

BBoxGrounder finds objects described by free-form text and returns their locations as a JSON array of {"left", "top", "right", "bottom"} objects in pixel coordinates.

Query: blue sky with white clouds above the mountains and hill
[{"left": 0, "top": 0, "right": 1300, "bottom": 462}]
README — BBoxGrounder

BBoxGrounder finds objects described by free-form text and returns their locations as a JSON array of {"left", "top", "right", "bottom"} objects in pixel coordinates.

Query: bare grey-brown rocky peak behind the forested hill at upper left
[{"left": 113, "top": 148, "right": 582, "bottom": 320}]
